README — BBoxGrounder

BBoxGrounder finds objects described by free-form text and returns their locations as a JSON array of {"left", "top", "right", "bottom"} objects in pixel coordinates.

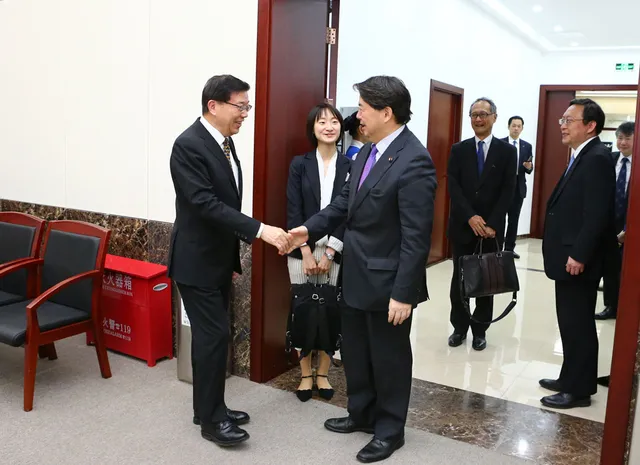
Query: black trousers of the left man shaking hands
[{"left": 176, "top": 283, "right": 231, "bottom": 423}]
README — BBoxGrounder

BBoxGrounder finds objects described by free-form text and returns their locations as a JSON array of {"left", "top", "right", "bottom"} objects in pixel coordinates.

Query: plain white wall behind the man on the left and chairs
[{"left": 0, "top": 0, "right": 258, "bottom": 221}]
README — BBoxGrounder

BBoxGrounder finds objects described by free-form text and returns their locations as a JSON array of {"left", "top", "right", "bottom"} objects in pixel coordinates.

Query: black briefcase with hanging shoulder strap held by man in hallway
[{"left": 460, "top": 239, "right": 520, "bottom": 324}]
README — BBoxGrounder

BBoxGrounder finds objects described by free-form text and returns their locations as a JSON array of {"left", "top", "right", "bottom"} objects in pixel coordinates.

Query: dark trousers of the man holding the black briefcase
[{"left": 449, "top": 239, "right": 497, "bottom": 337}]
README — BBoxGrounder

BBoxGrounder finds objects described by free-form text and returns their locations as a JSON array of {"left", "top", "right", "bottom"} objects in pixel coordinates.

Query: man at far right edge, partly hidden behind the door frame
[{"left": 595, "top": 121, "right": 635, "bottom": 320}]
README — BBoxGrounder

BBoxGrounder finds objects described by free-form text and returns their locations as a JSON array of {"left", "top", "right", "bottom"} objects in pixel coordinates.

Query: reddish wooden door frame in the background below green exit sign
[{"left": 530, "top": 84, "right": 638, "bottom": 239}]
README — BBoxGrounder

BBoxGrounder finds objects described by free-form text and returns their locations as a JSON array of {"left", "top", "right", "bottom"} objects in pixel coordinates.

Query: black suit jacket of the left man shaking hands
[{"left": 169, "top": 120, "right": 260, "bottom": 288}]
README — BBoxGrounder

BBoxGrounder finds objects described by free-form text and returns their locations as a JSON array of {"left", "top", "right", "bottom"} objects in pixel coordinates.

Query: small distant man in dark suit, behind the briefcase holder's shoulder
[{"left": 502, "top": 116, "right": 533, "bottom": 258}]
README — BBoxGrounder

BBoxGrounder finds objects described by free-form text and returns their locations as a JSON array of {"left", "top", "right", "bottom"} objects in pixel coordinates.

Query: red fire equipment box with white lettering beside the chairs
[{"left": 87, "top": 255, "right": 173, "bottom": 367}]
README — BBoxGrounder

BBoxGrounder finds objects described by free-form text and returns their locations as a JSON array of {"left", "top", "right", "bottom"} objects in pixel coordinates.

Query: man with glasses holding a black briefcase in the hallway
[{"left": 447, "top": 97, "right": 517, "bottom": 350}]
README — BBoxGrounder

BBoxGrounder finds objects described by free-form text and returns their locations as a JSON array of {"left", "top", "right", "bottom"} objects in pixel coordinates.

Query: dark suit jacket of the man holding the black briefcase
[{"left": 447, "top": 137, "right": 517, "bottom": 244}]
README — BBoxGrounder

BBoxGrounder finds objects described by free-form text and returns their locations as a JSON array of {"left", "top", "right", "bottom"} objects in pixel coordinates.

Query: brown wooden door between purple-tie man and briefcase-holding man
[{"left": 427, "top": 80, "right": 464, "bottom": 264}]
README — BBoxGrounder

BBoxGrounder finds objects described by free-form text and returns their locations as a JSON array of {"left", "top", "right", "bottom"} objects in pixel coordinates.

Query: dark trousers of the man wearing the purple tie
[{"left": 340, "top": 308, "right": 413, "bottom": 440}]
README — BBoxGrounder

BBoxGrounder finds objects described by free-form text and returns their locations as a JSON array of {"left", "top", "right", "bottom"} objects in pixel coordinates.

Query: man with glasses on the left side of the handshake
[{"left": 169, "top": 75, "right": 289, "bottom": 446}]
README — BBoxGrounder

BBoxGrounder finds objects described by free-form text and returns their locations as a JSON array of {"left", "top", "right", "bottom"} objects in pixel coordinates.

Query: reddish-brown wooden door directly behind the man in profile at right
[{"left": 531, "top": 90, "right": 576, "bottom": 238}]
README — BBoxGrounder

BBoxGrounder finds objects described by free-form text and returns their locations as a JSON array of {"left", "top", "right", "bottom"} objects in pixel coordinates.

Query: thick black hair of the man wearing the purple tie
[{"left": 353, "top": 76, "right": 412, "bottom": 124}]
